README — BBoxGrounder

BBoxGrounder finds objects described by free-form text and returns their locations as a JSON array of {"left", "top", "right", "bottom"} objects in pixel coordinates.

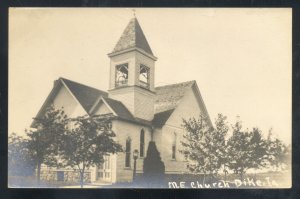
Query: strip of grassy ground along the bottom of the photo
[{"left": 8, "top": 172, "right": 291, "bottom": 189}]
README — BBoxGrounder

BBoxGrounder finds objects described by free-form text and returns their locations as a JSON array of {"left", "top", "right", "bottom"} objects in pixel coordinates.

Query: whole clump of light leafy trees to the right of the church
[{"left": 180, "top": 114, "right": 290, "bottom": 180}]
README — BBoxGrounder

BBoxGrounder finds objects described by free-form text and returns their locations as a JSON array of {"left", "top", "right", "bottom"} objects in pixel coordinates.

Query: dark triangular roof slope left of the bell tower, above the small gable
[{"left": 59, "top": 78, "right": 108, "bottom": 113}]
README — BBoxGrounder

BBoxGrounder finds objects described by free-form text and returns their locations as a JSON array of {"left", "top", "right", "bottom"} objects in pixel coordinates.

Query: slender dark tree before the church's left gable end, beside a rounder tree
[{"left": 26, "top": 106, "right": 67, "bottom": 184}]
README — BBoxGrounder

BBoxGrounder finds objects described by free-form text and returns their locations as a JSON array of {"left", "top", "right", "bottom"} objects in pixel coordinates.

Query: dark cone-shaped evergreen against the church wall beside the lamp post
[{"left": 143, "top": 141, "right": 165, "bottom": 187}]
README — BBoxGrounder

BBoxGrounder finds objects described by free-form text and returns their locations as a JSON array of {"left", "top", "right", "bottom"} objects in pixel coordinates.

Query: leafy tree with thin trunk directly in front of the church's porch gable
[{"left": 58, "top": 115, "right": 122, "bottom": 187}]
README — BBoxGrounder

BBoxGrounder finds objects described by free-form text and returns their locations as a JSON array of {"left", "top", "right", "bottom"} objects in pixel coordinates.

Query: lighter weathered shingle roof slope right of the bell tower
[{"left": 154, "top": 80, "right": 196, "bottom": 113}]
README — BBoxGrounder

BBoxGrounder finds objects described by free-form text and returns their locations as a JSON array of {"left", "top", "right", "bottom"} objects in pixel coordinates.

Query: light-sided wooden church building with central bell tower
[{"left": 33, "top": 17, "right": 210, "bottom": 184}]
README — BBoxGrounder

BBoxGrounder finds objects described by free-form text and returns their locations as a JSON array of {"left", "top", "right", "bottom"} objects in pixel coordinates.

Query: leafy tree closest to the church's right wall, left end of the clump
[{"left": 180, "top": 114, "right": 228, "bottom": 181}]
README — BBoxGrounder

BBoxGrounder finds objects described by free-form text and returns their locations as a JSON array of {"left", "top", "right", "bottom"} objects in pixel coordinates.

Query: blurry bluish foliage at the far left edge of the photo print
[{"left": 8, "top": 133, "right": 34, "bottom": 176}]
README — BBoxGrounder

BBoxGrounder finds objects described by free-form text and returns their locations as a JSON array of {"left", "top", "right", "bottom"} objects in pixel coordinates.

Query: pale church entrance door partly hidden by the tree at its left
[{"left": 97, "top": 156, "right": 112, "bottom": 182}]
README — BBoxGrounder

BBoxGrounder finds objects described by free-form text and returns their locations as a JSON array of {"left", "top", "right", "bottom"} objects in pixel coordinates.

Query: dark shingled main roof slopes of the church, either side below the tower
[{"left": 60, "top": 78, "right": 195, "bottom": 126}]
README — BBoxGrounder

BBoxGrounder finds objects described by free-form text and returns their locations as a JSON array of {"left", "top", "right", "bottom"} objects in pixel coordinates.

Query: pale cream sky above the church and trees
[{"left": 9, "top": 8, "right": 292, "bottom": 144}]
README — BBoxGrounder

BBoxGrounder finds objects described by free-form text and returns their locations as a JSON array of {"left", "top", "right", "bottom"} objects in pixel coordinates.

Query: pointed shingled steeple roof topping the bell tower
[{"left": 112, "top": 17, "right": 153, "bottom": 56}]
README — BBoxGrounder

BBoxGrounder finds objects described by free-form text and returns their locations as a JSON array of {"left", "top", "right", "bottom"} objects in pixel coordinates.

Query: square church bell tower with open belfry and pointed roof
[{"left": 108, "top": 17, "right": 157, "bottom": 121}]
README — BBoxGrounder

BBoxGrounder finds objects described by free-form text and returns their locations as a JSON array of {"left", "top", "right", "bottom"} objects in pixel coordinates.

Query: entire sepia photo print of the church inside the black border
[{"left": 7, "top": 7, "right": 292, "bottom": 189}]
